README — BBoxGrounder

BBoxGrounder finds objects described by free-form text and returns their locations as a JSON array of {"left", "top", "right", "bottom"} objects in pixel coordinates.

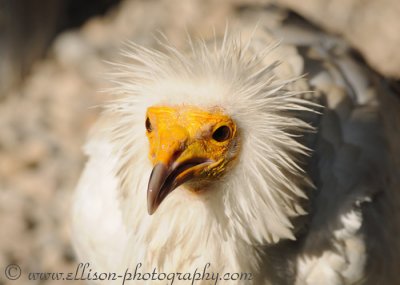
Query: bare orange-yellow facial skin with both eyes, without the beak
[{"left": 145, "top": 105, "right": 237, "bottom": 180}]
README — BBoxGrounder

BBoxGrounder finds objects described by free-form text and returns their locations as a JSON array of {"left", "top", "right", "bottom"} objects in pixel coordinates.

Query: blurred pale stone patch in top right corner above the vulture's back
[{"left": 276, "top": 0, "right": 400, "bottom": 79}]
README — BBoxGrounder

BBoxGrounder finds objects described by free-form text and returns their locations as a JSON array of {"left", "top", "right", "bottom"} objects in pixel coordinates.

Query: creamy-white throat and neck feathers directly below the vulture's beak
[{"left": 123, "top": 181, "right": 296, "bottom": 284}]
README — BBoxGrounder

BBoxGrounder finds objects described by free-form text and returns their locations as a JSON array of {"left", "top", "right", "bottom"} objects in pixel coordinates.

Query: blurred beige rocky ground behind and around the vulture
[{"left": 0, "top": 0, "right": 400, "bottom": 284}]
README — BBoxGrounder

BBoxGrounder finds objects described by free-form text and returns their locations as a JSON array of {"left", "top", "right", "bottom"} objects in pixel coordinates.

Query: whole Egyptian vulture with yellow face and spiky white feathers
[{"left": 73, "top": 11, "right": 400, "bottom": 285}]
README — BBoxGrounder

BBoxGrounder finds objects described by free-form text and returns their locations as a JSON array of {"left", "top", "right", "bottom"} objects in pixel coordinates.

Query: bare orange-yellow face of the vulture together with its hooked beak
[{"left": 145, "top": 105, "right": 238, "bottom": 214}]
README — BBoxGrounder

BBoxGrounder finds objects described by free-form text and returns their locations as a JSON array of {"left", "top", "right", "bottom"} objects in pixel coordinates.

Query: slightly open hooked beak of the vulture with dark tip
[{"left": 147, "top": 158, "right": 211, "bottom": 215}]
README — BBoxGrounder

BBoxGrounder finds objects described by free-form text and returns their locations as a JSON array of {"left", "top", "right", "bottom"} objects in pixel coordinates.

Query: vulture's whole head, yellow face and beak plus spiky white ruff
[{"left": 107, "top": 31, "right": 312, "bottom": 269}]
